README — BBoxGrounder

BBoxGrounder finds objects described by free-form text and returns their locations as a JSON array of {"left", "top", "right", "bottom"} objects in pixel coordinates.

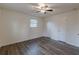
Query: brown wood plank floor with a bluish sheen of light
[{"left": 0, "top": 37, "right": 79, "bottom": 55}]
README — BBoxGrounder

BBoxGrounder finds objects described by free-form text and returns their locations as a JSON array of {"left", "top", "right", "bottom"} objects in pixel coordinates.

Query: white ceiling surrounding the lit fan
[{"left": 0, "top": 3, "right": 79, "bottom": 17}]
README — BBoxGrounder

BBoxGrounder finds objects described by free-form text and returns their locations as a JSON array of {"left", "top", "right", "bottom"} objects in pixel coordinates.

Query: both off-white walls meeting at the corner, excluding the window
[{"left": 0, "top": 9, "right": 79, "bottom": 46}]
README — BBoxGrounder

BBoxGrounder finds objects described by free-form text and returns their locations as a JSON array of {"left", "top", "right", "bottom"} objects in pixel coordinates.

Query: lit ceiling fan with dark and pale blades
[{"left": 33, "top": 3, "right": 53, "bottom": 14}]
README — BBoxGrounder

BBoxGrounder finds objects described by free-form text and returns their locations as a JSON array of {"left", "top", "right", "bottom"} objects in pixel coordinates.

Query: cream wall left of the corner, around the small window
[{"left": 0, "top": 9, "right": 43, "bottom": 46}]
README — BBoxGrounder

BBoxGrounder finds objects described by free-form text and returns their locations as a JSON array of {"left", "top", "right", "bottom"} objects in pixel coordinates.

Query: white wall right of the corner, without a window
[{"left": 44, "top": 10, "right": 79, "bottom": 47}]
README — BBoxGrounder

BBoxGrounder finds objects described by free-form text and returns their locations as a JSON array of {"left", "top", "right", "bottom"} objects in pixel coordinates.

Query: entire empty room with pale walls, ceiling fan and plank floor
[{"left": 0, "top": 3, "right": 79, "bottom": 55}]
